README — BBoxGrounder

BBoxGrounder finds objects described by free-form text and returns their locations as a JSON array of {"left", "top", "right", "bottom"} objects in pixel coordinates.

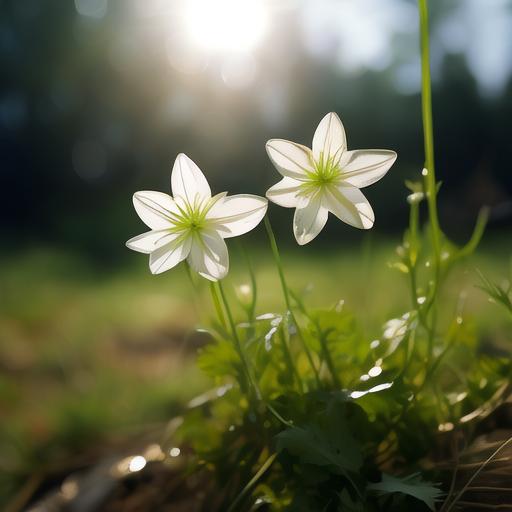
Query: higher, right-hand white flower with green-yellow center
[{"left": 266, "top": 112, "right": 397, "bottom": 245}]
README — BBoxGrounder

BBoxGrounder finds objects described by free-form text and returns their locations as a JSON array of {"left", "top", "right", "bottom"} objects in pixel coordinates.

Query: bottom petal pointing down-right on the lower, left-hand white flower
[{"left": 187, "top": 230, "right": 229, "bottom": 281}]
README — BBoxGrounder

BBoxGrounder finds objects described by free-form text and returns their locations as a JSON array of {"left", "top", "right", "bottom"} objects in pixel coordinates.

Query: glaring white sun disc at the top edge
[{"left": 185, "top": 0, "right": 267, "bottom": 52}]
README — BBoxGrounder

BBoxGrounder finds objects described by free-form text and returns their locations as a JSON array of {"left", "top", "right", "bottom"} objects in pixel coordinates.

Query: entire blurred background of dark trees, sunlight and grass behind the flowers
[{"left": 0, "top": 0, "right": 512, "bottom": 508}]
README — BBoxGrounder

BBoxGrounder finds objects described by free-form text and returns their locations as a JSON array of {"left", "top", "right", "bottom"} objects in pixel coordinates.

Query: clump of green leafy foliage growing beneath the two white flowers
[{"left": 178, "top": 220, "right": 512, "bottom": 512}]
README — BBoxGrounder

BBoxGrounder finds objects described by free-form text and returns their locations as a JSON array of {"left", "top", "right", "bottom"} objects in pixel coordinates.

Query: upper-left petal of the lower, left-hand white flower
[{"left": 133, "top": 190, "right": 178, "bottom": 229}]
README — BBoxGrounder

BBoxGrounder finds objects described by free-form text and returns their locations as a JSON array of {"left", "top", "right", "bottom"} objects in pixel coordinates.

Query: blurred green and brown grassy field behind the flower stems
[{"left": 0, "top": 238, "right": 512, "bottom": 504}]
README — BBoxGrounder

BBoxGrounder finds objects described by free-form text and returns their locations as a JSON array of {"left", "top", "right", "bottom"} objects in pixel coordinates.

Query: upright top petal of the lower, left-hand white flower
[{"left": 171, "top": 153, "right": 212, "bottom": 205}]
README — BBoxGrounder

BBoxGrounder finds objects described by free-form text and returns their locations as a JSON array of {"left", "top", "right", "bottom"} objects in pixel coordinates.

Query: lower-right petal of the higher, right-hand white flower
[{"left": 323, "top": 185, "right": 375, "bottom": 229}]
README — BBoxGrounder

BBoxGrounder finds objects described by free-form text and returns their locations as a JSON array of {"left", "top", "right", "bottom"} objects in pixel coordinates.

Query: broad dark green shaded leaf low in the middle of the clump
[{"left": 277, "top": 407, "right": 363, "bottom": 474}]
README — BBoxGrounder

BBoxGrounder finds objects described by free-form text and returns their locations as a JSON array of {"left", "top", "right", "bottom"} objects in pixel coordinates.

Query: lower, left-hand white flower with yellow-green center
[{"left": 126, "top": 153, "right": 267, "bottom": 281}]
